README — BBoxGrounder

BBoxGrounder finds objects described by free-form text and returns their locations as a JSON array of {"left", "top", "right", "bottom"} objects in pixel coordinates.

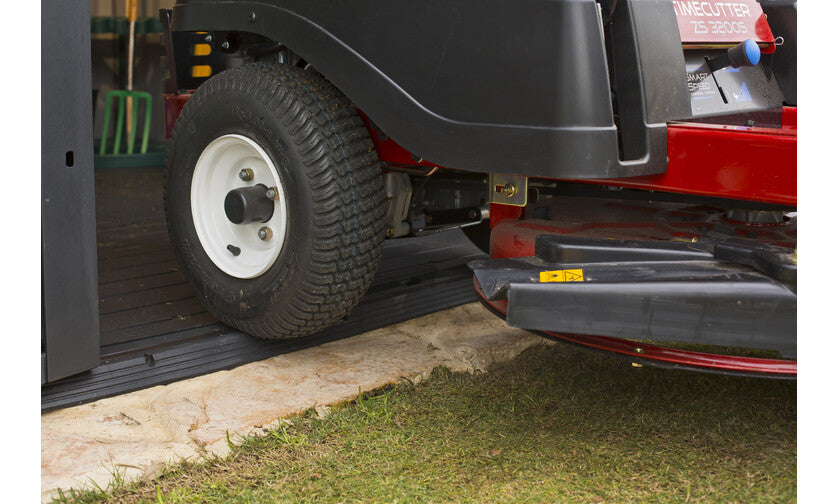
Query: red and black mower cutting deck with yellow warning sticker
[{"left": 470, "top": 196, "right": 797, "bottom": 377}]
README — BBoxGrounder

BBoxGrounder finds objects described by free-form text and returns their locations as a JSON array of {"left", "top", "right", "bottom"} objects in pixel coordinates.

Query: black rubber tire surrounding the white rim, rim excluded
[{"left": 165, "top": 64, "right": 385, "bottom": 339}]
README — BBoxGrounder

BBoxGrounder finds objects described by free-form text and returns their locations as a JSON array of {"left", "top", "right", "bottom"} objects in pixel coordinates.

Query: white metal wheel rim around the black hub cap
[{"left": 190, "top": 135, "right": 288, "bottom": 278}]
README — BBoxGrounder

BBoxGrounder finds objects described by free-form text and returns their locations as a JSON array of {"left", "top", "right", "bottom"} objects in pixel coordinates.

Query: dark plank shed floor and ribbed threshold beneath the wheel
[{"left": 41, "top": 167, "right": 485, "bottom": 411}]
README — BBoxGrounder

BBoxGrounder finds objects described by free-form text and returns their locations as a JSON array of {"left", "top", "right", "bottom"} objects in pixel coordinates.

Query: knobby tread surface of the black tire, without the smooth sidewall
[{"left": 166, "top": 63, "right": 385, "bottom": 339}]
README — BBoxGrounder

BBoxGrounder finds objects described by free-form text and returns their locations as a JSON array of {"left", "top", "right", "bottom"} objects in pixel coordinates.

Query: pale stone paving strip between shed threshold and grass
[{"left": 41, "top": 303, "right": 545, "bottom": 502}]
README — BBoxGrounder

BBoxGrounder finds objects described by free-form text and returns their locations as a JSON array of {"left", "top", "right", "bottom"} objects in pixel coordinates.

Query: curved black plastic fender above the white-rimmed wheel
[{"left": 172, "top": 0, "right": 690, "bottom": 178}]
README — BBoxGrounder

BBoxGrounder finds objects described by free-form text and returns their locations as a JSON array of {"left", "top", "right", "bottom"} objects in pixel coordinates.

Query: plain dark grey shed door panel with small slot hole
[{"left": 41, "top": 0, "right": 99, "bottom": 381}]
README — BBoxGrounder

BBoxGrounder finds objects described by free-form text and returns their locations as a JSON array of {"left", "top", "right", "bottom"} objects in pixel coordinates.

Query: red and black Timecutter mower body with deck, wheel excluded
[{"left": 165, "top": 0, "right": 797, "bottom": 377}]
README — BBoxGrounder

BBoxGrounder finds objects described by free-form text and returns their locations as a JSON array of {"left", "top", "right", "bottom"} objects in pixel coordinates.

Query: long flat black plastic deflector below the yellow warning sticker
[{"left": 507, "top": 281, "right": 796, "bottom": 357}]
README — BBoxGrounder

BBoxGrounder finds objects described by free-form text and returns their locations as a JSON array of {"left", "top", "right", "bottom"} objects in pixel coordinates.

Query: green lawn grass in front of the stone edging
[{"left": 58, "top": 345, "right": 796, "bottom": 503}]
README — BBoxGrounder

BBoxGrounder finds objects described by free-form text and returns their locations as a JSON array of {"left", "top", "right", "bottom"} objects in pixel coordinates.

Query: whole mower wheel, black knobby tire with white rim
[{"left": 165, "top": 64, "right": 385, "bottom": 339}]
